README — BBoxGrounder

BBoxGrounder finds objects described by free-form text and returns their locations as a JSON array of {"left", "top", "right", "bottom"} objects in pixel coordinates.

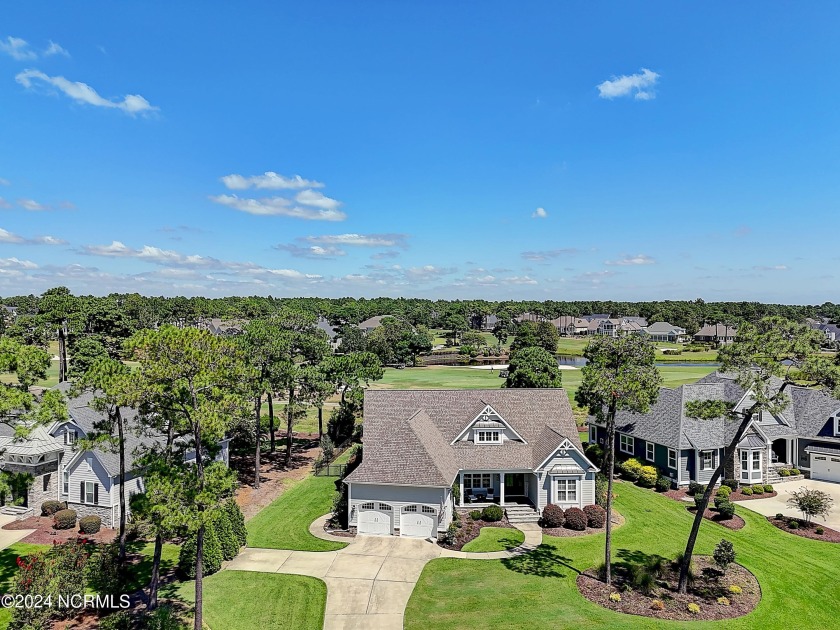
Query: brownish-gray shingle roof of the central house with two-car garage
[{"left": 347, "top": 389, "right": 582, "bottom": 486}]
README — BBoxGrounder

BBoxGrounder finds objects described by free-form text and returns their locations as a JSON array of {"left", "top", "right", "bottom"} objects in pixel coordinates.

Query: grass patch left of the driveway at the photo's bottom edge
[{"left": 178, "top": 571, "right": 327, "bottom": 630}]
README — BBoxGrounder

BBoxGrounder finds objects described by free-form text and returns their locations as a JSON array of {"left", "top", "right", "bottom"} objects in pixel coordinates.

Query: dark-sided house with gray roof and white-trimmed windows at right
[{"left": 589, "top": 372, "right": 840, "bottom": 486}]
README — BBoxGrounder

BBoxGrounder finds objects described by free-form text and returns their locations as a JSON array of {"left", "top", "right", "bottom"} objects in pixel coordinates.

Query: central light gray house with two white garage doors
[{"left": 345, "top": 389, "right": 598, "bottom": 538}]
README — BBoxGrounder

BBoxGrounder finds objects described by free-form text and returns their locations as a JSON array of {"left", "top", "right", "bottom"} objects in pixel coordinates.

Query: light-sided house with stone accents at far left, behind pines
[{"left": 0, "top": 383, "right": 229, "bottom": 527}]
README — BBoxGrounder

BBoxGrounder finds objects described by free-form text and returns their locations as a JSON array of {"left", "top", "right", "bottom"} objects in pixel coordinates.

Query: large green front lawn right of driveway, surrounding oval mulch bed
[{"left": 405, "top": 484, "right": 840, "bottom": 630}]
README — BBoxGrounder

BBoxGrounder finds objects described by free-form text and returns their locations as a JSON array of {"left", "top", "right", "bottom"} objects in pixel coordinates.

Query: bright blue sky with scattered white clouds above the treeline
[{"left": 0, "top": 0, "right": 840, "bottom": 303}]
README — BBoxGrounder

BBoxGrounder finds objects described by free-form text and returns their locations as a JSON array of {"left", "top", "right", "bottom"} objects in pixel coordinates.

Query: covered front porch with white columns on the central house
[{"left": 458, "top": 470, "right": 537, "bottom": 509}]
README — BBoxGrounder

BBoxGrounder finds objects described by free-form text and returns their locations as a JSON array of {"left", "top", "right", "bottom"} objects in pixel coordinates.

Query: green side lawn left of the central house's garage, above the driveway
[{"left": 247, "top": 475, "right": 346, "bottom": 551}]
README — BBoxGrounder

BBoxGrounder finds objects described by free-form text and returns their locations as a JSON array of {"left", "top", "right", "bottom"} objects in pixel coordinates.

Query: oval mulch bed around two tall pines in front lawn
[{"left": 577, "top": 556, "right": 761, "bottom": 621}]
